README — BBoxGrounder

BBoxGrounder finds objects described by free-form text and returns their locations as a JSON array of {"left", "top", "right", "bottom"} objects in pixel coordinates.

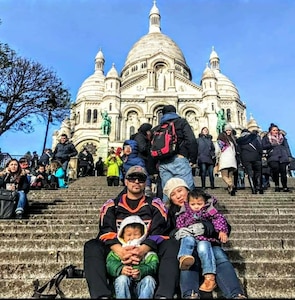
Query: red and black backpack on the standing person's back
[{"left": 151, "top": 121, "right": 177, "bottom": 160}]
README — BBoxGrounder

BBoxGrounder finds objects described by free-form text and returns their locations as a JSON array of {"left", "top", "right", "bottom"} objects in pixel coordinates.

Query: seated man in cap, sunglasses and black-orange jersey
[{"left": 84, "top": 166, "right": 179, "bottom": 299}]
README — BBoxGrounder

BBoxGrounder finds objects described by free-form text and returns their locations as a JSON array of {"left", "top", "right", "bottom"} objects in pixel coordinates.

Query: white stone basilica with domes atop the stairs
[{"left": 52, "top": 1, "right": 259, "bottom": 160}]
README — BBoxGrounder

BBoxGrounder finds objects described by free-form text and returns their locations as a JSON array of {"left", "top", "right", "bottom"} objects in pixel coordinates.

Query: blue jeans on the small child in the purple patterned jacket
[{"left": 177, "top": 236, "right": 216, "bottom": 275}]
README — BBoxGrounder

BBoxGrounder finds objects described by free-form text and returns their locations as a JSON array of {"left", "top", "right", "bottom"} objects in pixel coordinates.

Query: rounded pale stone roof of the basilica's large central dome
[{"left": 125, "top": 32, "right": 186, "bottom": 66}]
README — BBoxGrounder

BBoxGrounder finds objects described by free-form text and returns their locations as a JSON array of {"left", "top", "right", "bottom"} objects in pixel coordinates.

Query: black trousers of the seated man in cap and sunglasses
[{"left": 84, "top": 239, "right": 179, "bottom": 299}]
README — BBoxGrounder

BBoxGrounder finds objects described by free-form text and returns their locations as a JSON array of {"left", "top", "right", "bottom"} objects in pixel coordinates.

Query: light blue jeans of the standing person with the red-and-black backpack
[{"left": 159, "top": 155, "right": 195, "bottom": 203}]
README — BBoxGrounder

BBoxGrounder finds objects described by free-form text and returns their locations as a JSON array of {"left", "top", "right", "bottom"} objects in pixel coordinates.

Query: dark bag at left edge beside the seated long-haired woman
[{"left": 0, "top": 189, "right": 18, "bottom": 219}]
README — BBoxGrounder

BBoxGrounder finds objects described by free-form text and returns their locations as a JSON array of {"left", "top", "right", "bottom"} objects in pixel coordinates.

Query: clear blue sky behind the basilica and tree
[{"left": 0, "top": 0, "right": 295, "bottom": 156}]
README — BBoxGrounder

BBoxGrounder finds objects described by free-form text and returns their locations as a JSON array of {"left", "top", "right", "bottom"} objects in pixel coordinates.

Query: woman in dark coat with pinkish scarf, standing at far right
[{"left": 262, "top": 123, "right": 292, "bottom": 192}]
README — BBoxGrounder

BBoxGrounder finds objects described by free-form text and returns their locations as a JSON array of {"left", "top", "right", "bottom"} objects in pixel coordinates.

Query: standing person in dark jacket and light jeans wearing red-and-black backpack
[{"left": 151, "top": 105, "right": 198, "bottom": 202}]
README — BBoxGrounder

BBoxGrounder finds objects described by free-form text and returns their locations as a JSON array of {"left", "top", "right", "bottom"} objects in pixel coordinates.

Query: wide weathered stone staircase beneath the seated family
[{"left": 0, "top": 177, "right": 295, "bottom": 299}]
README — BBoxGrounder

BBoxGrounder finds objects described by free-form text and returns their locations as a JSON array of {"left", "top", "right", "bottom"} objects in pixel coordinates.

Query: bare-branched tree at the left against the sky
[{"left": 0, "top": 43, "right": 71, "bottom": 136}]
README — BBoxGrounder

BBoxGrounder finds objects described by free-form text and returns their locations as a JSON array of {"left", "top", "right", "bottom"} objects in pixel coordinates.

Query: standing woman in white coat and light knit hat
[{"left": 215, "top": 124, "right": 237, "bottom": 196}]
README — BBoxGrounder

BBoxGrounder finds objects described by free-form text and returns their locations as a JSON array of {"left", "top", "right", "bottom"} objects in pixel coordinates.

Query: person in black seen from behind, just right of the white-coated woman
[{"left": 236, "top": 129, "right": 263, "bottom": 194}]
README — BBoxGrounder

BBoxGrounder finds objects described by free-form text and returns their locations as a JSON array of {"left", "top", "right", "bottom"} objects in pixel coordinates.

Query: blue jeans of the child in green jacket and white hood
[{"left": 114, "top": 275, "right": 156, "bottom": 299}]
